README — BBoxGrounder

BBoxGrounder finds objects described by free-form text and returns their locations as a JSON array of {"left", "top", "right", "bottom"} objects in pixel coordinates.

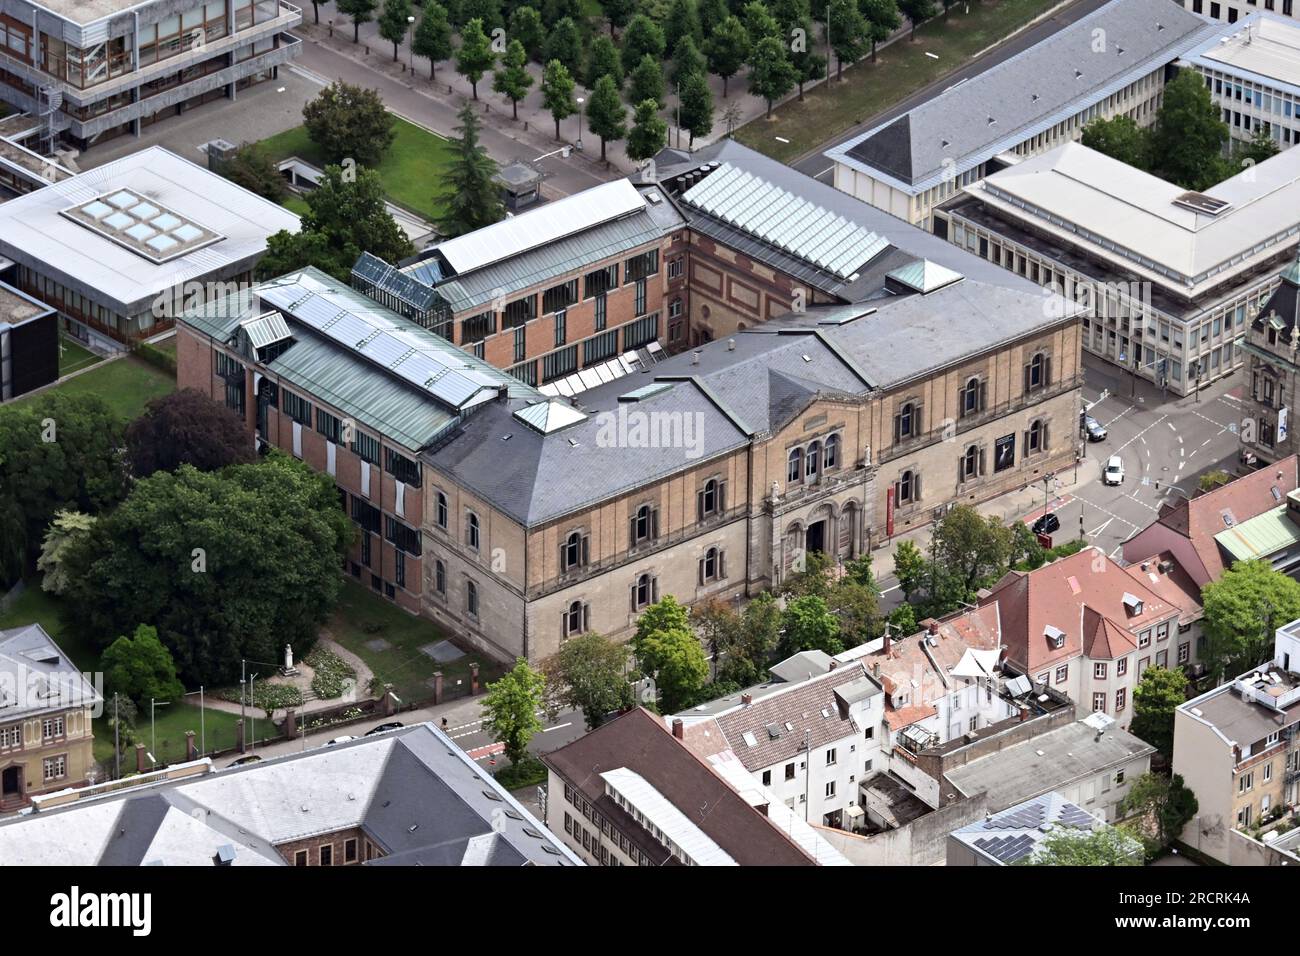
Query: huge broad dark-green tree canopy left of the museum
[{"left": 66, "top": 451, "right": 355, "bottom": 685}]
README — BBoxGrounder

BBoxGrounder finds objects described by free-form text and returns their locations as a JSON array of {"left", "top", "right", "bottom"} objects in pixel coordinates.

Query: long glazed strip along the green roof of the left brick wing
[{"left": 257, "top": 274, "right": 507, "bottom": 410}]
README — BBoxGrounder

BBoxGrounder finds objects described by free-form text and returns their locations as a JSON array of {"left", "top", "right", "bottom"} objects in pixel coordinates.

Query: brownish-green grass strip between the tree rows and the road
[{"left": 743, "top": 0, "right": 1058, "bottom": 163}]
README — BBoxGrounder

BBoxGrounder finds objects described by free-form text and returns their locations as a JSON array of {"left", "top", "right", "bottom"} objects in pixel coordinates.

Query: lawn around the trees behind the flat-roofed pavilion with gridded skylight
[{"left": 261, "top": 120, "right": 451, "bottom": 221}]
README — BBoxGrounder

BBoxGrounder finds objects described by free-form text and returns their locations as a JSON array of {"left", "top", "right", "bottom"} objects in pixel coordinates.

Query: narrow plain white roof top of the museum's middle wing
[{"left": 437, "top": 179, "right": 646, "bottom": 276}]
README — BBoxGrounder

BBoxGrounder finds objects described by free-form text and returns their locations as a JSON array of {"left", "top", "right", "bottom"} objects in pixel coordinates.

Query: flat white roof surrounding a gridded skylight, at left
[{"left": 0, "top": 146, "right": 299, "bottom": 312}]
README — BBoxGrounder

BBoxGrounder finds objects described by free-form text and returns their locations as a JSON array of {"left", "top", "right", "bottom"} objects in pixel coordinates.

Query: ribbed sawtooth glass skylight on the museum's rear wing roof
[{"left": 681, "top": 163, "right": 889, "bottom": 280}]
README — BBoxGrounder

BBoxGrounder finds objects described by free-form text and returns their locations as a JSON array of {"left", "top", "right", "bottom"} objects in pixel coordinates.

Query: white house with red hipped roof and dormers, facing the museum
[{"left": 979, "top": 548, "right": 1199, "bottom": 727}]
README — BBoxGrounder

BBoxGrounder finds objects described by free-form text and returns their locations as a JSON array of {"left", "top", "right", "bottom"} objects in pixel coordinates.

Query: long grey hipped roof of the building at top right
[{"left": 826, "top": 0, "right": 1218, "bottom": 194}]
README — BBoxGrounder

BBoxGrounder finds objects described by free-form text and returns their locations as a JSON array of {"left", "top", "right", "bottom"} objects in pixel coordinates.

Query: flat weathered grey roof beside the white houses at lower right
[{"left": 946, "top": 721, "right": 1156, "bottom": 813}]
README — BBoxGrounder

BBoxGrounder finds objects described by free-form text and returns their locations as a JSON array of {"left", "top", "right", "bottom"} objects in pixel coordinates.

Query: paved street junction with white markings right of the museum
[{"left": 1066, "top": 356, "right": 1244, "bottom": 557}]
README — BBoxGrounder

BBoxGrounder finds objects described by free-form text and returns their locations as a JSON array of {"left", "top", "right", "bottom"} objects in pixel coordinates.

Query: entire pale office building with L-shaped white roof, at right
[{"left": 935, "top": 143, "right": 1300, "bottom": 395}]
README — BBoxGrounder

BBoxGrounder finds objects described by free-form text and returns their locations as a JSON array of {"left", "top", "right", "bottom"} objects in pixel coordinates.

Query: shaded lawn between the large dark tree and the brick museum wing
[{"left": 328, "top": 581, "right": 502, "bottom": 702}]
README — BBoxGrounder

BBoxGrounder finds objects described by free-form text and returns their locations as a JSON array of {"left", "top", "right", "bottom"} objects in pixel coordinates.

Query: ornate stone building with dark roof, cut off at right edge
[{"left": 1238, "top": 250, "right": 1300, "bottom": 467}]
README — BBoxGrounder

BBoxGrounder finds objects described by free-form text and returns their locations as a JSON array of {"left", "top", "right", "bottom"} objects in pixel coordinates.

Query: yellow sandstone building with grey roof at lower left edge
[{"left": 0, "top": 624, "right": 104, "bottom": 811}]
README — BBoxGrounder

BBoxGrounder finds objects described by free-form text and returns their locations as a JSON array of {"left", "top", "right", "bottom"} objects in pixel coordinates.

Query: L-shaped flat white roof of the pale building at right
[{"left": 967, "top": 143, "right": 1300, "bottom": 291}]
